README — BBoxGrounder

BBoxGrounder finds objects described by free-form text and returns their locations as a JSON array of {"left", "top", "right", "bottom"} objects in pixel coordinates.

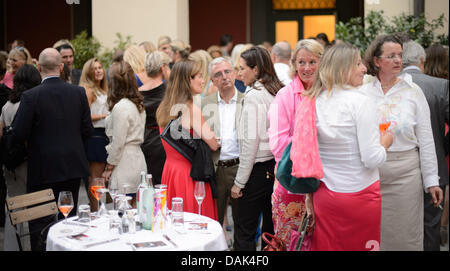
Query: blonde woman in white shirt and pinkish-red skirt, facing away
[{"left": 298, "top": 44, "right": 393, "bottom": 251}]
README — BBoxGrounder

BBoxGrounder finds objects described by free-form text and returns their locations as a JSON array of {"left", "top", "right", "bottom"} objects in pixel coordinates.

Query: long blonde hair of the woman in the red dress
[{"left": 156, "top": 60, "right": 201, "bottom": 127}]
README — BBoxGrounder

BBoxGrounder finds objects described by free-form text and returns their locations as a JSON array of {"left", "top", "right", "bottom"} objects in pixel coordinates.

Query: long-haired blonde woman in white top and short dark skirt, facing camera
[{"left": 80, "top": 58, "right": 109, "bottom": 211}]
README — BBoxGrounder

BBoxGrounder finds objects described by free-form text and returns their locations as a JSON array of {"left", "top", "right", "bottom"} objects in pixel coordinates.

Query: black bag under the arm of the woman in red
[{"left": 160, "top": 115, "right": 199, "bottom": 163}]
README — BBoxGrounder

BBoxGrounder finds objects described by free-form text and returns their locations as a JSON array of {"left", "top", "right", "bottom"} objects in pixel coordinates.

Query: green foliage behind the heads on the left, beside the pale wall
[{"left": 70, "top": 31, "right": 132, "bottom": 69}]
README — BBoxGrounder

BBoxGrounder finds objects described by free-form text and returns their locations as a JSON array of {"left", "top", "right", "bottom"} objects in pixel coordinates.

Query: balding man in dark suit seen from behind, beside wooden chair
[{"left": 13, "top": 48, "right": 93, "bottom": 250}]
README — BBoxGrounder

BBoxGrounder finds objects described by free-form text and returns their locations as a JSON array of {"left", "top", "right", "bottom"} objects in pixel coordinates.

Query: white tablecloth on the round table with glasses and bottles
[{"left": 47, "top": 213, "right": 228, "bottom": 251}]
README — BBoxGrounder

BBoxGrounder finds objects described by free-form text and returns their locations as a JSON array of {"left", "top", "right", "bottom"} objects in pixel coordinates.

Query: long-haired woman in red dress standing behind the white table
[{"left": 156, "top": 61, "right": 220, "bottom": 220}]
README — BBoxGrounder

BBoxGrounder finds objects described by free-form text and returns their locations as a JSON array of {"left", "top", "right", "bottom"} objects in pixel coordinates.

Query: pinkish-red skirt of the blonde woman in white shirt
[{"left": 311, "top": 181, "right": 381, "bottom": 251}]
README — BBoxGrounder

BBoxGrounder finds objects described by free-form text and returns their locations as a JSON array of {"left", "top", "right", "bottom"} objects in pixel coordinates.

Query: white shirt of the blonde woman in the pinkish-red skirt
[{"left": 316, "top": 87, "right": 386, "bottom": 193}]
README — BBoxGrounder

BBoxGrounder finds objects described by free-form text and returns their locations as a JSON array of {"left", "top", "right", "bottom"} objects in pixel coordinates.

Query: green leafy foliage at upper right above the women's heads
[{"left": 336, "top": 10, "right": 448, "bottom": 52}]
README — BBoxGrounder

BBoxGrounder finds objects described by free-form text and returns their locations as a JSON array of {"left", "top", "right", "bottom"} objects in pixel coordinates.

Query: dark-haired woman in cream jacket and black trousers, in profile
[{"left": 231, "top": 46, "right": 283, "bottom": 250}]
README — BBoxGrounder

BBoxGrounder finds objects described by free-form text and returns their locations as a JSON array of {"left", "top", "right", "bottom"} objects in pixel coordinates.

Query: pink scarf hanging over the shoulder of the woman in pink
[{"left": 291, "top": 94, "right": 323, "bottom": 180}]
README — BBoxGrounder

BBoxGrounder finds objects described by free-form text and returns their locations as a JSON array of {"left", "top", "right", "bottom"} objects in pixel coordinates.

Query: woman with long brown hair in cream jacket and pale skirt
[{"left": 103, "top": 61, "right": 147, "bottom": 206}]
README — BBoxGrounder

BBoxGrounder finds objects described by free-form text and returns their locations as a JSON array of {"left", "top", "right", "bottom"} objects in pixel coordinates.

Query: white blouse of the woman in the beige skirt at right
[{"left": 361, "top": 73, "right": 439, "bottom": 192}]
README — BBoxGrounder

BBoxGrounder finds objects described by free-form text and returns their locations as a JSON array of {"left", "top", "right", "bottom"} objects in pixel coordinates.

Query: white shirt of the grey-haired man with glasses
[{"left": 217, "top": 90, "right": 239, "bottom": 160}]
